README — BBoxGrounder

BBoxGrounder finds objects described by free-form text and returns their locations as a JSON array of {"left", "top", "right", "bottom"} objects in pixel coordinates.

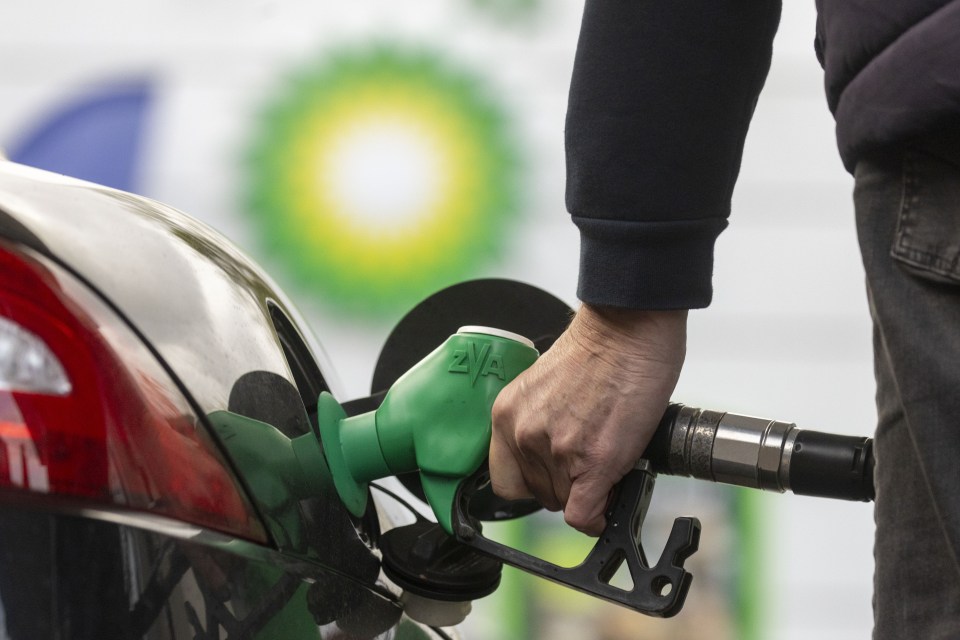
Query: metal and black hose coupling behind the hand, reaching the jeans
[{"left": 644, "top": 404, "right": 874, "bottom": 502}]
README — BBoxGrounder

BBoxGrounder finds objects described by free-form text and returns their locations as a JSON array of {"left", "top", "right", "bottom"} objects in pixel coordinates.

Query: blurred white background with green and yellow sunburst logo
[{"left": 0, "top": 0, "right": 874, "bottom": 640}]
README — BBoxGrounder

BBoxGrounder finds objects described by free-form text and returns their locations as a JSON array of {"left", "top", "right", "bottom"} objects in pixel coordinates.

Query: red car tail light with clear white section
[{"left": 0, "top": 243, "right": 267, "bottom": 542}]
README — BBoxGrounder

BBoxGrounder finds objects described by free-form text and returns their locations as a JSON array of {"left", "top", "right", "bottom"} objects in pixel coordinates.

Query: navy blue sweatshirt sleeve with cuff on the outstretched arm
[{"left": 566, "top": 0, "right": 780, "bottom": 309}]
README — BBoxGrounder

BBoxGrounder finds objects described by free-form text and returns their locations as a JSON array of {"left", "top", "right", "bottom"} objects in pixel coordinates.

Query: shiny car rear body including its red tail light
[{"left": 0, "top": 160, "right": 455, "bottom": 640}]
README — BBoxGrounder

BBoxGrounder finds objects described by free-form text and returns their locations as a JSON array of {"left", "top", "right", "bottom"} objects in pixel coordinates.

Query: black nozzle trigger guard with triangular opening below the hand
[{"left": 452, "top": 460, "right": 700, "bottom": 618}]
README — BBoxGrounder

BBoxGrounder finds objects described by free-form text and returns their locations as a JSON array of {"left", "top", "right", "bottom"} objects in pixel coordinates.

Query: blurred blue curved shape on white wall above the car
[{"left": 8, "top": 81, "right": 152, "bottom": 192}]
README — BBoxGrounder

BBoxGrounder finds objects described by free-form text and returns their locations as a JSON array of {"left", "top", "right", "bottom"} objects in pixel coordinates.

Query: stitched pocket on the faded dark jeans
[{"left": 890, "top": 151, "right": 960, "bottom": 284}]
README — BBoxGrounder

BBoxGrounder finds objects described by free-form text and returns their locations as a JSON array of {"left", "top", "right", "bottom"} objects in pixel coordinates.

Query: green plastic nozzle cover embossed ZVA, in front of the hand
[{"left": 317, "top": 326, "right": 539, "bottom": 535}]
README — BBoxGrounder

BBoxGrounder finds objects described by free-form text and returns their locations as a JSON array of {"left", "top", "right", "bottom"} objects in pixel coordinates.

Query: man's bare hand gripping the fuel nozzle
[{"left": 490, "top": 305, "right": 687, "bottom": 535}]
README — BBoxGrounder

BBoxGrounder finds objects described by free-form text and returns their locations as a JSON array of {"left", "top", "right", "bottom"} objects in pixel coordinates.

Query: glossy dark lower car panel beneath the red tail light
[{"left": 0, "top": 508, "right": 410, "bottom": 640}]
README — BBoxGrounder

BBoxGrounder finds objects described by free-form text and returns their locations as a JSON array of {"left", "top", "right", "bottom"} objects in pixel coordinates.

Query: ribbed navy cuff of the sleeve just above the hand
[{"left": 573, "top": 216, "right": 727, "bottom": 309}]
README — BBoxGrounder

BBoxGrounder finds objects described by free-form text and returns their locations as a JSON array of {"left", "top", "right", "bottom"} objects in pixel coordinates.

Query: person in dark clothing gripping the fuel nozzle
[{"left": 490, "top": 0, "right": 960, "bottom": 639}]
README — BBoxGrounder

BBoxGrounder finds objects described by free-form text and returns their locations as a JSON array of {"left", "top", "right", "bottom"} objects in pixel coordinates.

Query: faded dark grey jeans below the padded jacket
[{"left": 854, "top": 148, "right": 960, "bottom": 640}]
